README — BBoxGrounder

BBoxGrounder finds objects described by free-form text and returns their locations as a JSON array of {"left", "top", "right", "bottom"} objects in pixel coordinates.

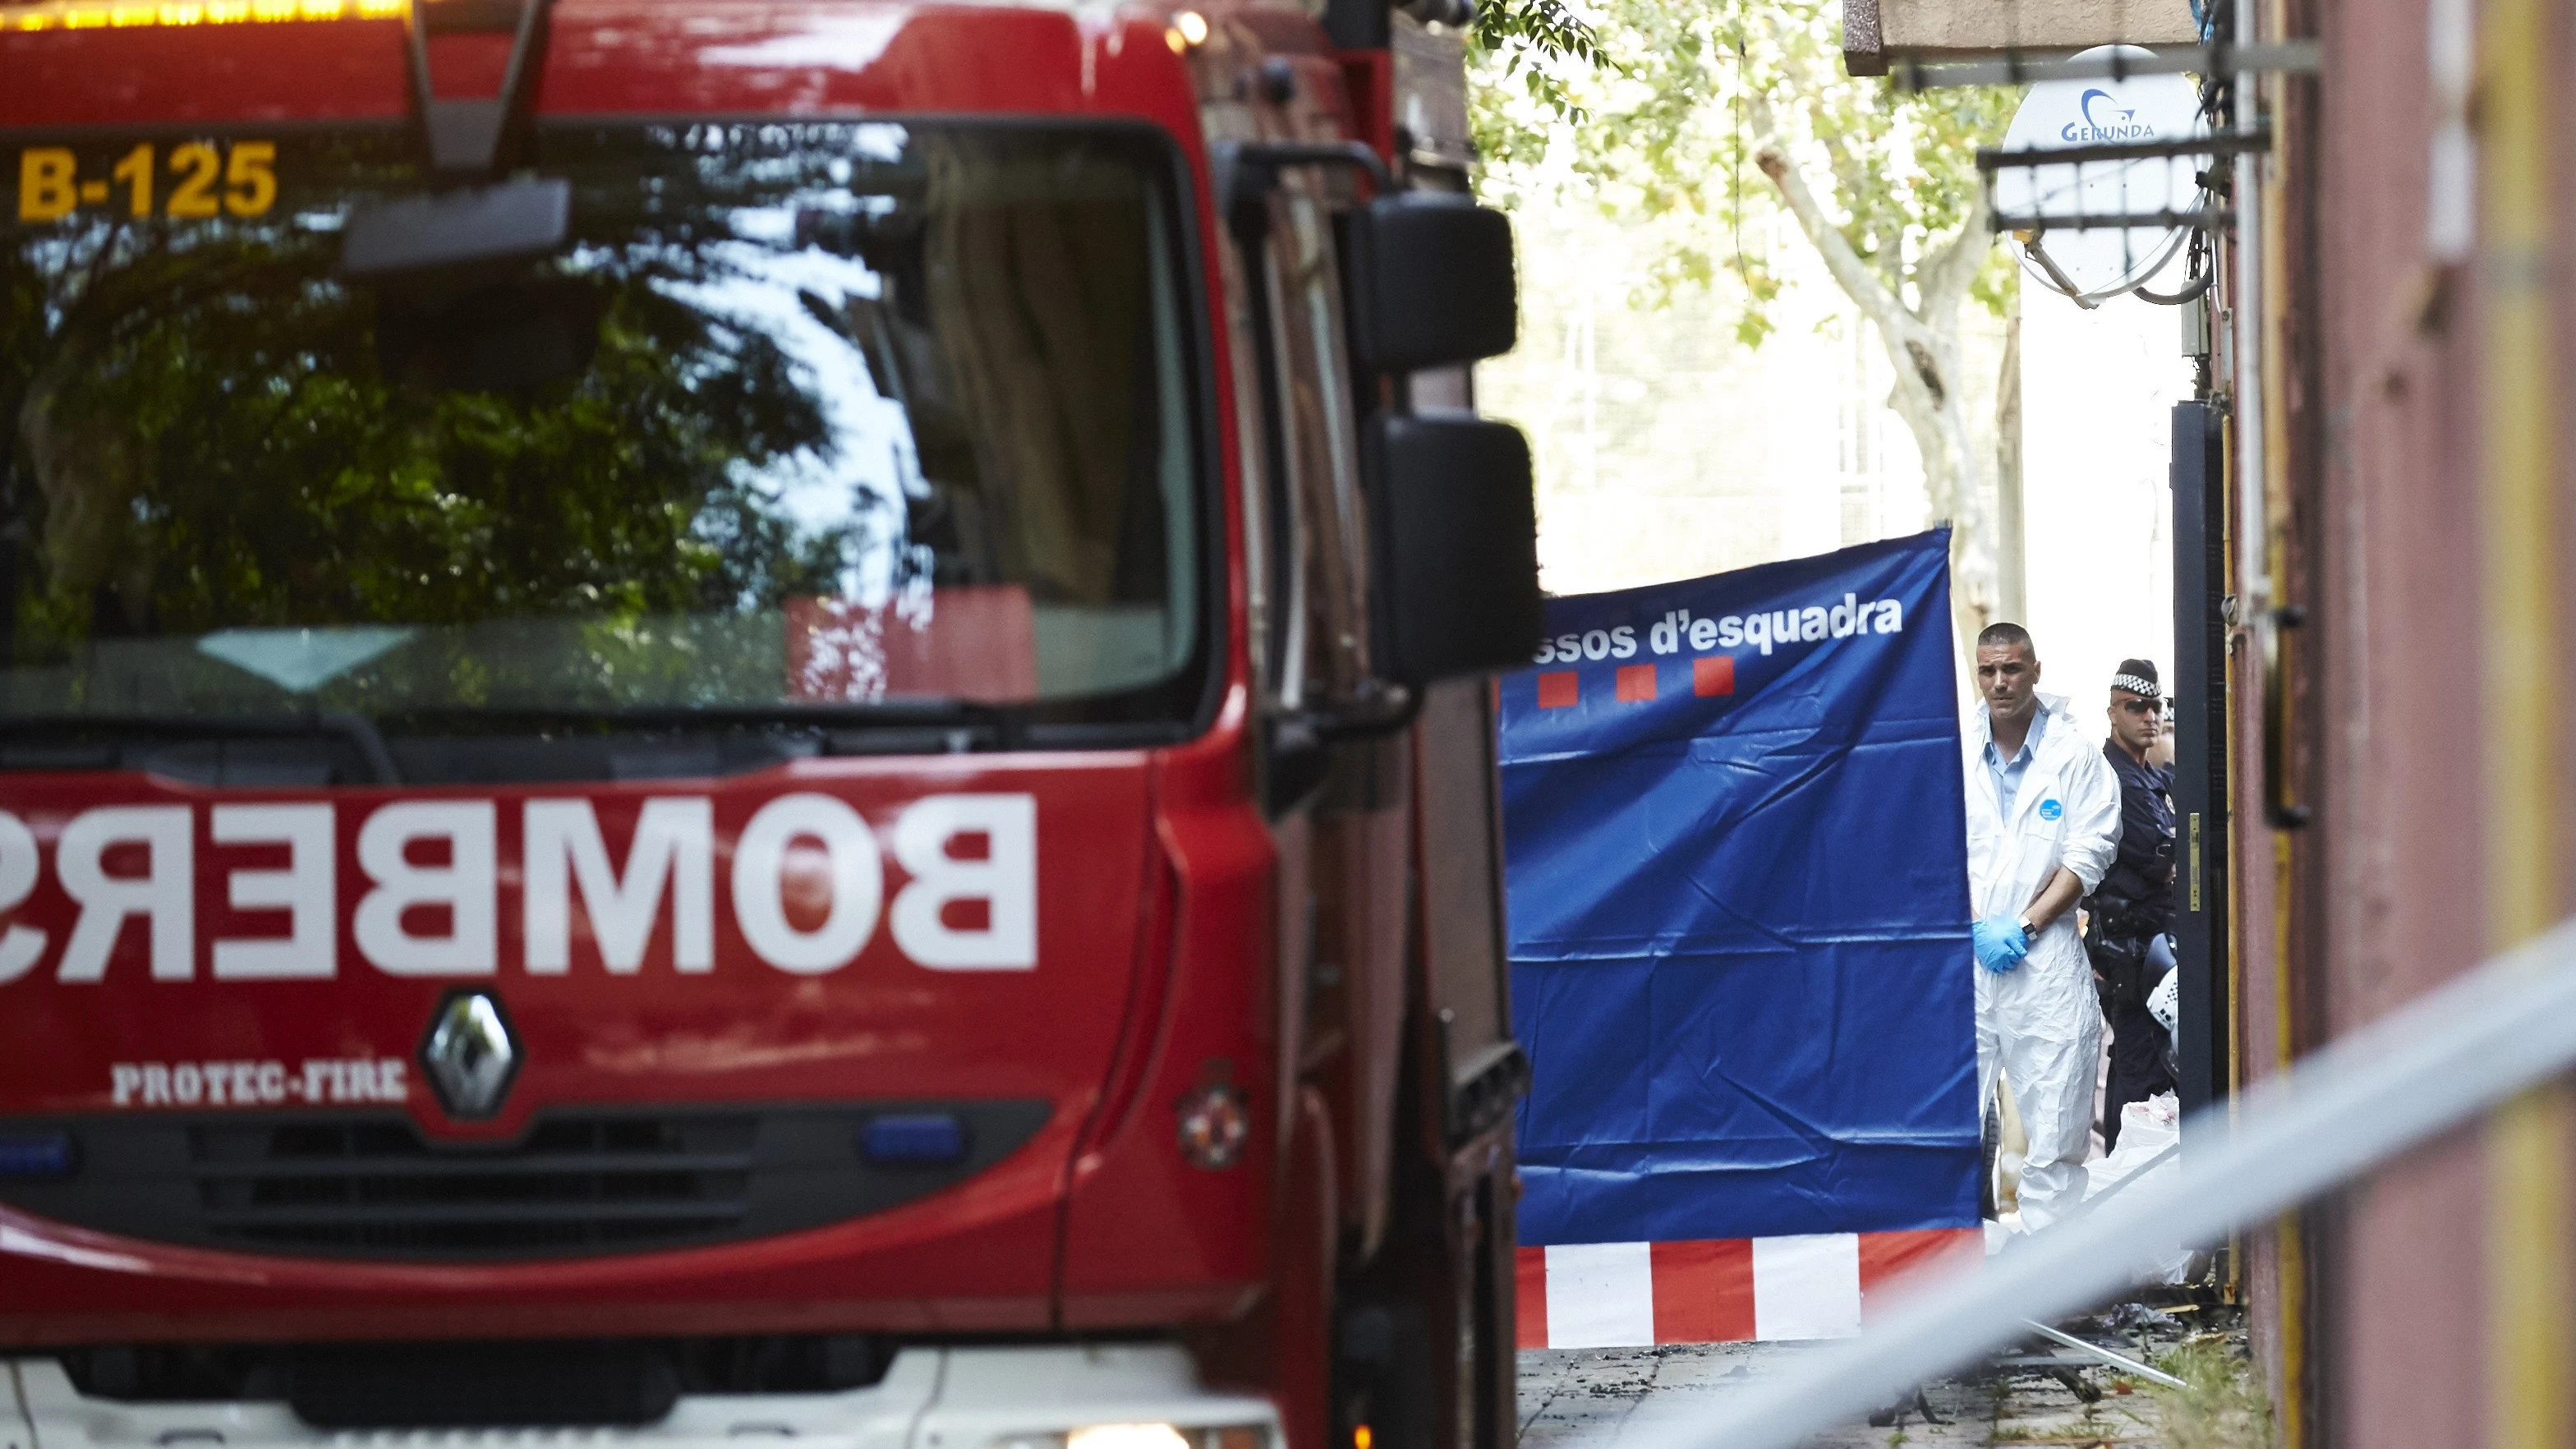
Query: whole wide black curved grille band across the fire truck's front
[{"left": 0, "top": 1101, "right": 1048, "bottom": 1261}]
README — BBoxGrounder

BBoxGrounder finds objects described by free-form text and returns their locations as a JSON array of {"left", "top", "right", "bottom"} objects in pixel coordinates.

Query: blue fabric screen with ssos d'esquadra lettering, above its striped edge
[{"left": 1502, "top": 531, "right": 1978, "bottom": 1243}]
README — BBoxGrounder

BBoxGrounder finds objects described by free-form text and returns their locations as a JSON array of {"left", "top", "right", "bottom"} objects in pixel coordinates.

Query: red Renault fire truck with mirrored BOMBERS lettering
[{"left": 0, "top": 0, "right": 1538, "bottom": 1449}]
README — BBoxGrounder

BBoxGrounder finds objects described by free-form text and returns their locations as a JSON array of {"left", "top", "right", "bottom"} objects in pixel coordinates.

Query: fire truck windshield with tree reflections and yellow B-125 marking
[{"left": 0, "top": 122, "right": 1213, "bottom": 740}]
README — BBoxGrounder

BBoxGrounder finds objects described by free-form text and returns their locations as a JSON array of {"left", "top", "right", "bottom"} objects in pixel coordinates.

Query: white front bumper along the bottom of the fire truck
[{"left": 0, "top": 1343, "right": 1281, "bottom": 1449}]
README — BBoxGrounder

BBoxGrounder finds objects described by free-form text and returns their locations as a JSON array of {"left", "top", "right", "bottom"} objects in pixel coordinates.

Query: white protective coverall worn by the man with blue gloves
[{"left": 1963, "top": 693, "right": 2120, "bottom": 1217}]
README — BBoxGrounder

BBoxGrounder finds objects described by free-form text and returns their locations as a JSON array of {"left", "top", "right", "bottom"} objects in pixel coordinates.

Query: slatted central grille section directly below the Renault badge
[{"left": 188, "top": 1114, "right": 760, "bottom": 1253}]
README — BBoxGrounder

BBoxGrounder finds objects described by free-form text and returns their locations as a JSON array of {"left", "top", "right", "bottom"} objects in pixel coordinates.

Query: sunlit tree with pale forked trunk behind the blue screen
[{"left": 1474, "top": 0, "right": 2017, "bottom": 614}]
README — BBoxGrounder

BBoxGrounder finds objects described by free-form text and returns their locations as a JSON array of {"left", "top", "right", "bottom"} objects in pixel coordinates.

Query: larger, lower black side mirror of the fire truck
[{"left": 1368, "top": 412, "right": 1546, "bottom": 686}]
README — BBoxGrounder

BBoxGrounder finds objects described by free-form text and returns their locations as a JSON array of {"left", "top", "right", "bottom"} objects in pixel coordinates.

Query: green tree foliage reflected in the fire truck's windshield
[{"left": 0, "top": 128, "right": 855, "bottom": 704}]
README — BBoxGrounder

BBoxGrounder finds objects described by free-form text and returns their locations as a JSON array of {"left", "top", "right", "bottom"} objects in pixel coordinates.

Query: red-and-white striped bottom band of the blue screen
[{"left": 1517, "top": 1227, "right": 1986, "bottom": 1349}]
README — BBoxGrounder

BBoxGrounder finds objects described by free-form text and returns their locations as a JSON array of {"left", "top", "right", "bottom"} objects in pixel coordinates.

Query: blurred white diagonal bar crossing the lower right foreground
[{"left": 1603, "top": 921, "right": 2576, "bottom": 1449}]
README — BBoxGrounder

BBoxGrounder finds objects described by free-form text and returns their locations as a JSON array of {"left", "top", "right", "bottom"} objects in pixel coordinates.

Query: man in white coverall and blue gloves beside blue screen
[{"left": 1963, "top": 624, "right": 2120, "bottom": 1232}]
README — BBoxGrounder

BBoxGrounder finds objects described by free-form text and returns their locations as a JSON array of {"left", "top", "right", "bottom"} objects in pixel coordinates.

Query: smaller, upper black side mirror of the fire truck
[{"left": 1345, "top": 191, "right": 1520, "bottom": 374}]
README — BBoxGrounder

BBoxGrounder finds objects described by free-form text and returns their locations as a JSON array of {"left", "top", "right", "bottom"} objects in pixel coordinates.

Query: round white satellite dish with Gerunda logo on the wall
[{"left": 1994, "top": 46, "right": 2210, "bottom": 307}]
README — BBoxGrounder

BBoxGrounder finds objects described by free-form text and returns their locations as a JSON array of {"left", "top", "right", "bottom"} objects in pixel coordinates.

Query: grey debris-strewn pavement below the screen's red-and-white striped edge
[{"left": 1520, "top": 1310, "right": 2252, "bottom": 1449}]
